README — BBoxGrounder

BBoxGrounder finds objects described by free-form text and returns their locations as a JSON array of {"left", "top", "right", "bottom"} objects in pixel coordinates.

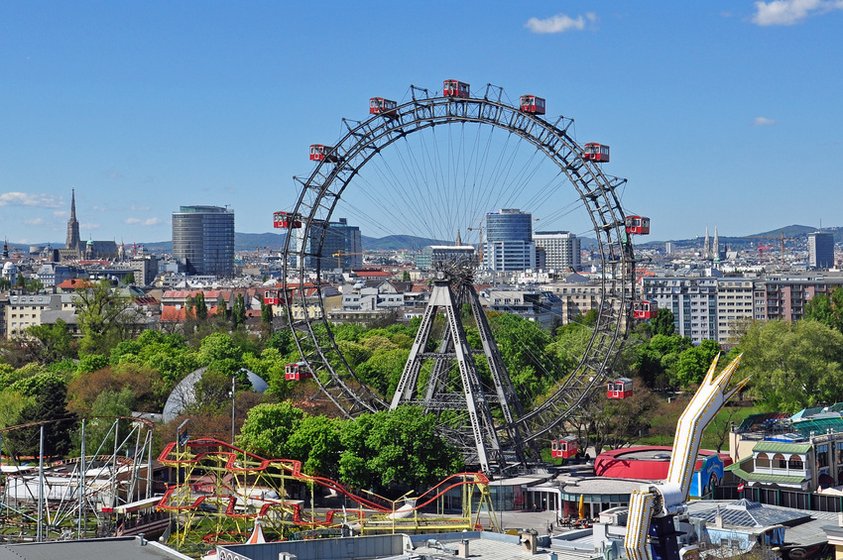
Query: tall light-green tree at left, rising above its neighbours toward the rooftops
[{"left": 74, "top": 280, "right": 137, "bottom": 355}]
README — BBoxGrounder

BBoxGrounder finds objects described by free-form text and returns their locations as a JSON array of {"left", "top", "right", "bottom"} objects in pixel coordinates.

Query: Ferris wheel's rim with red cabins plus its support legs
[{"left": 274, "top": 79, "right": 655, "bottom": 474}]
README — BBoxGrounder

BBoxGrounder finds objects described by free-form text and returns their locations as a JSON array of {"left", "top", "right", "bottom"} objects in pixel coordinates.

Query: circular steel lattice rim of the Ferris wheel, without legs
[{"left": 283, "top": 85, "right": 635, "bottom": 456}]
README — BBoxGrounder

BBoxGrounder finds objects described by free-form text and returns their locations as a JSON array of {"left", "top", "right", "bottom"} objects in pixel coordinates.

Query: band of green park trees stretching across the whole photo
[{"left": 0, "top": 283, "right": 843, "bottom": 492}]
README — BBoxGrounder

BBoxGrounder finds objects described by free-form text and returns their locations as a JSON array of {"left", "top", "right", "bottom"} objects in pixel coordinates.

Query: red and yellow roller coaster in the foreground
[{"left": 157, "top": 438, "right": 498, "bottom": 549}]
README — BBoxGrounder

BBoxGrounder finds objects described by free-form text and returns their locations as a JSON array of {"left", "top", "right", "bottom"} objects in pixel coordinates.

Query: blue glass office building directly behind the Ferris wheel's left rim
[{"left": 292, "top": 218, "right": 363, "bottom": 271}]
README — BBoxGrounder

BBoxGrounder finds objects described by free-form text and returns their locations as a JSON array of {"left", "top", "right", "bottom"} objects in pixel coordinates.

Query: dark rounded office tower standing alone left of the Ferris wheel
[{"left": 173, "top": 206, "right": 234, "bottom": 277}]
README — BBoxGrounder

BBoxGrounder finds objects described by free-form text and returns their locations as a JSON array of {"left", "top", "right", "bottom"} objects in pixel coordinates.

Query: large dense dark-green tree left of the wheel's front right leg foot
[{"left": 339, "top": 406, "right": 464, "bottom": 495}]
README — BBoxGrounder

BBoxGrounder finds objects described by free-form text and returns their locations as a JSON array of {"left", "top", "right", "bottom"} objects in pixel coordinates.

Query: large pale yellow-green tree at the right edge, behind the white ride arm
[{"left": 739, "top": 321, "right": 843, "bottom": 412}]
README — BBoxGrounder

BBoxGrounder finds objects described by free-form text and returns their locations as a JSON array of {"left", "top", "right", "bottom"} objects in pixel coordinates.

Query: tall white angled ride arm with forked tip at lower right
[{"left": 624, "top": 355, "right": 749, "bottom": 560}]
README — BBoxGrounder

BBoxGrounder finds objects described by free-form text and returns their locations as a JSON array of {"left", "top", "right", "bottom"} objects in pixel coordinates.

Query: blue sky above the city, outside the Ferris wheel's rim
[{"left": 0, "top": 0, "right": 843, "bottom": 243}]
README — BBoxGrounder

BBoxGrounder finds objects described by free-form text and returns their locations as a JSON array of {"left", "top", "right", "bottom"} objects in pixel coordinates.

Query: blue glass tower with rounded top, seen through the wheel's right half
[{"left": 483, "top": 208, "right": 536, "bottom": 272}]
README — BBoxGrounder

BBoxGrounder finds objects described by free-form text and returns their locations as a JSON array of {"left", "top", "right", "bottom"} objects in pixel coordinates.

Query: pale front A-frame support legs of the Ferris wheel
[{"left": 390, "top": 280, "right": 506, "bottom": 472}]
